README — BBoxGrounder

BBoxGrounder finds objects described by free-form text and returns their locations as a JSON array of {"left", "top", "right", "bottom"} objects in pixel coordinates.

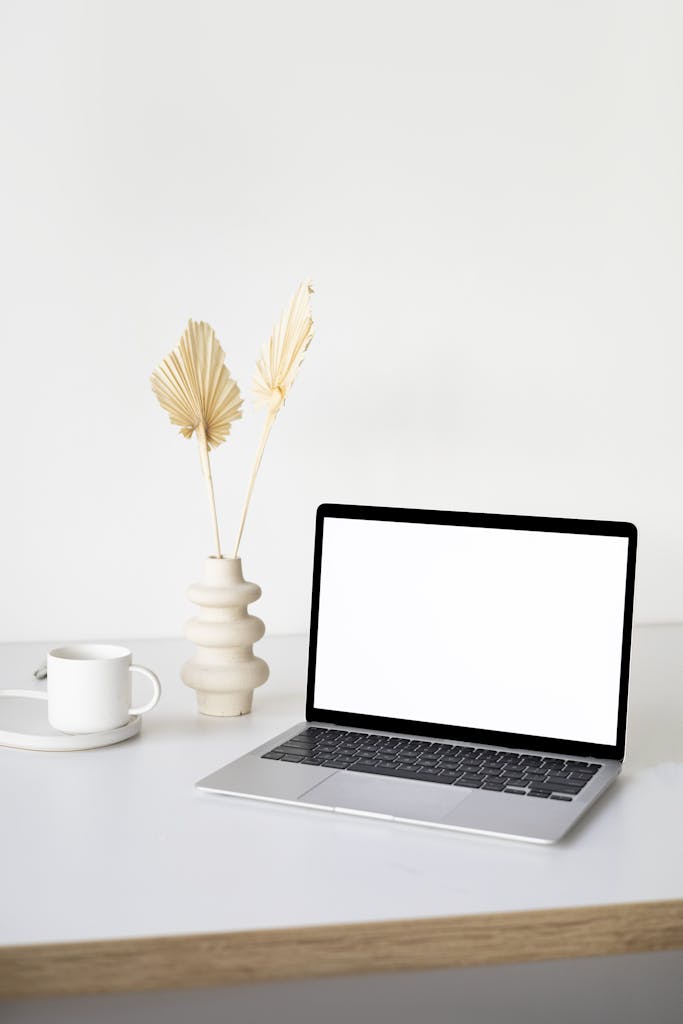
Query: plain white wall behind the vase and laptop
[{"left": 0, "top": 0, "right": 683, "bottom": 640}]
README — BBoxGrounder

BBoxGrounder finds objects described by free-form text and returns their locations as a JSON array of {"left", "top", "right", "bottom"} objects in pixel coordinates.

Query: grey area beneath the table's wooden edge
[{"left": 0, "top": 950, "right": 683, "bottom": 1024}]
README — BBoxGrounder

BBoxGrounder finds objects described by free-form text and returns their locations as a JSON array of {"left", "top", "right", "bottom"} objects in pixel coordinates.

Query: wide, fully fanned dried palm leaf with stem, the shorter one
[{"left": 152, "top": 321, "right": 242, "bottom": 558}]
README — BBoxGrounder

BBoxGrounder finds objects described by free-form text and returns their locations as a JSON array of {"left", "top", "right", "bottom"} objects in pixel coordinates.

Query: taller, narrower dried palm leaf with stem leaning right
[{"left": 232, "top": 282, "right": 313, "bottom": 558}]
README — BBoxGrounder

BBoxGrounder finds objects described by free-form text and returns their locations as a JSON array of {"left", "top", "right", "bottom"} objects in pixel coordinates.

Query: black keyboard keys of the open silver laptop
[{"left": 261, "top": 726, "right": 601, "bottom": 801}]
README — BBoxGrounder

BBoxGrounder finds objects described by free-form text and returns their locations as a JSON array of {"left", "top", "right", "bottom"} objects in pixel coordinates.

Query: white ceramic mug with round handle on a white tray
[{"left": 47, "top": 643, "right": 161, "bottom": 732}]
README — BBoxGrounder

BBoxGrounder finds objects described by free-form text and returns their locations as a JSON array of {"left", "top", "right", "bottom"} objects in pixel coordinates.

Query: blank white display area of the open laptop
[{"left": 314, "top": 518, "right": 628, "bottom": 744}]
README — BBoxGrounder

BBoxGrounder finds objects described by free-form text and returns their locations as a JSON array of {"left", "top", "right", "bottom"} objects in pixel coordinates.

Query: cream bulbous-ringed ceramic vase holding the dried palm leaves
[{"left": 180, "top": 558, "right": 268, "bottom": 717}]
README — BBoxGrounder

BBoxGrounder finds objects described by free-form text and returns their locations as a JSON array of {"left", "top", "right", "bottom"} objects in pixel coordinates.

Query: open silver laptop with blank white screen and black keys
[{"left": 197, "top": 505, "right": 637, "bottom": 843}]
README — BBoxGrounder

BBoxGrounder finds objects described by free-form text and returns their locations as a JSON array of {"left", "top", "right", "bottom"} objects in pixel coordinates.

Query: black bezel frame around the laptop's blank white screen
[{"left": 306, "top": 504, "right": 638, "bottom": 760}]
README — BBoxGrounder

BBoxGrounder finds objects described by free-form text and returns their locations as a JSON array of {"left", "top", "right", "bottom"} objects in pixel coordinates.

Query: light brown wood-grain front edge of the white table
[{"left": 0, "top": 900, "right": 683, "bottom": 998}]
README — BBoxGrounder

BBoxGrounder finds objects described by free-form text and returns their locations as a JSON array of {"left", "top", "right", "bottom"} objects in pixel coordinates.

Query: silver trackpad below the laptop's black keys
[{"left": 299, "top": 772, "right": 471, "bottom": 821}]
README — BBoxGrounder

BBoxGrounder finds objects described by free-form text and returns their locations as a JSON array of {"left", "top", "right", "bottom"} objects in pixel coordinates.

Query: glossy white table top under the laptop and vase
[{"left": 0, "top": 626, "right": 683, "bottom": 945}]
